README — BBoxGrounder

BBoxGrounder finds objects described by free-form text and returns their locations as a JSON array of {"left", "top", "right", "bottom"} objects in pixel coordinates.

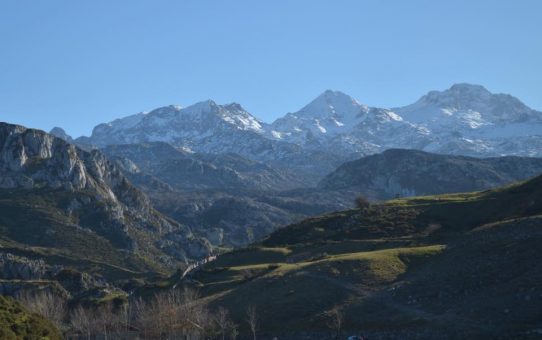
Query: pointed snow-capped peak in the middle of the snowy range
[{"left": 269, "top": 90, "right": 434, "bottom": 156}]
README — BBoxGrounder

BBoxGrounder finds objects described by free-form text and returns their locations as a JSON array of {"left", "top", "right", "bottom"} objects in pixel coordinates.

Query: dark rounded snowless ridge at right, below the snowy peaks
[{"left": 318, "top": 149, "right": 542, "bottom": 200}]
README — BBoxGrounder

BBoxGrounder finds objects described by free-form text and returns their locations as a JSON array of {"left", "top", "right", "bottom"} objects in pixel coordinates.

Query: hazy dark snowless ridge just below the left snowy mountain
[{"left": 102, "top": 142, "right": 303, "bottom": 191}]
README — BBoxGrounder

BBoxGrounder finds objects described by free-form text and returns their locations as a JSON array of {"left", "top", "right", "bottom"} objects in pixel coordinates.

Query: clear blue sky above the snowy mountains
[{"left": 0, "top": 0, "right": 542, "bottom": 136}]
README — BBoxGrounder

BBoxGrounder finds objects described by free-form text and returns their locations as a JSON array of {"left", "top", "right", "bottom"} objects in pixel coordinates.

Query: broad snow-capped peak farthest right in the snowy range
[{"left": 394, "top": 84, "right": 542, "bottom": 156}]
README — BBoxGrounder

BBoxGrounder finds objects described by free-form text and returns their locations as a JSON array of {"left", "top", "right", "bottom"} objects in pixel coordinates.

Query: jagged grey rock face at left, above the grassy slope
[{"left": 0, "top": 123, "right": 210, "bottom": 262}]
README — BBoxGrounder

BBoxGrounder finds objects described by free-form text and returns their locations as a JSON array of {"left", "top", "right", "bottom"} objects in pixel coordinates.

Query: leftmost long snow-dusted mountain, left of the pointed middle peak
[{"left": 76, "top": 100, "right": 343, "bottom": 184}]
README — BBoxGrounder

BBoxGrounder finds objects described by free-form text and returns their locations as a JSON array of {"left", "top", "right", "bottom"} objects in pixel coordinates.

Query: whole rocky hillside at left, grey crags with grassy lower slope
[{"left": 0, "top": 123, "right": 210, "bottom": 267}]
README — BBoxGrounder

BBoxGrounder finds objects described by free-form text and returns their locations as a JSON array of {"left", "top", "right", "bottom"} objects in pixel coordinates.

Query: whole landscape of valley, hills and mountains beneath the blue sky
[{"left": 0, "top": 84, "right": 542, "bottom": 339}]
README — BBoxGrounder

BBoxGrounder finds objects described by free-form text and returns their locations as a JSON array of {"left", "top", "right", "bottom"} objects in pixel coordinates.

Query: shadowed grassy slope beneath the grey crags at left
[{"left": 0, "top": 190, "right": 168, "bottom": 279}]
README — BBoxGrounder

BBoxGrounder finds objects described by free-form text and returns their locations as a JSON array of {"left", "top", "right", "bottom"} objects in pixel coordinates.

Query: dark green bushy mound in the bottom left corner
[{"left": 0, "top": 296, "right": 61, "bottom": 340}]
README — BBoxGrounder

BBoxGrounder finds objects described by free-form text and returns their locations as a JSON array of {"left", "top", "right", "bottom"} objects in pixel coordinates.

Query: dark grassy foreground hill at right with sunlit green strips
[{"left": 189, "top": 177, "right": 542, "bottom": 338}]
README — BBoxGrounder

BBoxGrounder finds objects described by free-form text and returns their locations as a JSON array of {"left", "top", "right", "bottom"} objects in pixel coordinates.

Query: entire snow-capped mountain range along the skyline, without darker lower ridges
[{"left": 57, "top": 84, "right": 542, "bottom": 185}]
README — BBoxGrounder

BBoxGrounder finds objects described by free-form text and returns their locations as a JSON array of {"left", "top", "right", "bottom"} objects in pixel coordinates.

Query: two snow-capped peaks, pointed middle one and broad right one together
[{"left": 269, "top": 84, "right": 542, "bottom": 156}]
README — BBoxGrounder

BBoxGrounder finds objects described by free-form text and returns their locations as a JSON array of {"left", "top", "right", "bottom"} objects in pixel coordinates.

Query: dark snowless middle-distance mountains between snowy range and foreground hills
[{"left": 89, "top": 142, "right": 542, "bottom": 247}]
